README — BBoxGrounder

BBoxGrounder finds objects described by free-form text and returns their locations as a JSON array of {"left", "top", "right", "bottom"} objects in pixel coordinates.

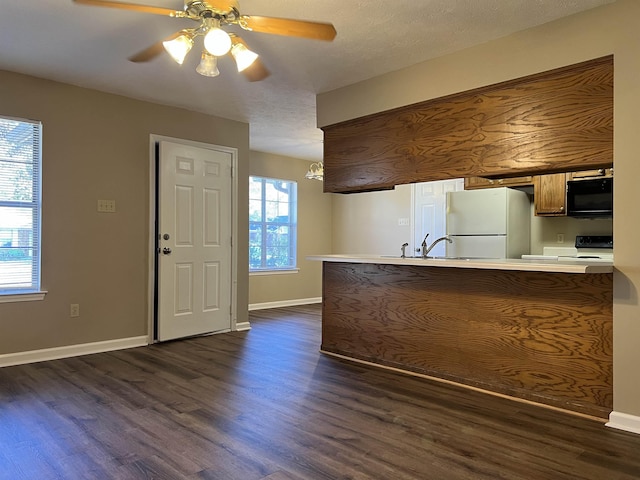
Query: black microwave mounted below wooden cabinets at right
[{"left": 567, "top": 177, "right": 613, "bottom": 218}]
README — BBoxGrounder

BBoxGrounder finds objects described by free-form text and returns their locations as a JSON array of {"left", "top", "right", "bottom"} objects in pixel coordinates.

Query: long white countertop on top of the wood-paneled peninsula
[{"left": 307, "top": 254, "right": 613, "bottom": 273}]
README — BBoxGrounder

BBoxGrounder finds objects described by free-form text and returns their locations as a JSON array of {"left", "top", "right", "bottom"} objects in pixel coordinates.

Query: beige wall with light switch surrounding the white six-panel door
[{"left": 0, "top": 71, "right": 249, "bottom": 354}]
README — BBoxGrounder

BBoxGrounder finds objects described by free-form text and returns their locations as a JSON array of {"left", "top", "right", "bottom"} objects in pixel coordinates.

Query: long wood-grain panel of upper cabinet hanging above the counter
[{"left": 323, "top": 56, "right": 613, "bottom": 193}]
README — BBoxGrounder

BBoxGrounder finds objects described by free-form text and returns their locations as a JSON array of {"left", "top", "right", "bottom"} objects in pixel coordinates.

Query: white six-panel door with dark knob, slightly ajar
[{"left": 157, "top": 141, "right": 233, "bottom": 341}]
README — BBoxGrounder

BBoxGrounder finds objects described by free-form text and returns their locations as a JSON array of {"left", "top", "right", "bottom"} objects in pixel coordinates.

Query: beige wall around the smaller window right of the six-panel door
[{"left": 249, "top": 151, "right": 332, "bottom": 306}]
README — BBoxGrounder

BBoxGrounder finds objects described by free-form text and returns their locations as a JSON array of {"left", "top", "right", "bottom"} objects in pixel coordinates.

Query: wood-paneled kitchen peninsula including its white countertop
[{"left": 308, "top": 255, "right": 613, "bottom": 420}]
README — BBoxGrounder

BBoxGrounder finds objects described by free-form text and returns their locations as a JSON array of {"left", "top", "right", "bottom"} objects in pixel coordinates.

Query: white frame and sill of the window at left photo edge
[{"left": 0, "top": 115, "right": 47, "bottom": 303}]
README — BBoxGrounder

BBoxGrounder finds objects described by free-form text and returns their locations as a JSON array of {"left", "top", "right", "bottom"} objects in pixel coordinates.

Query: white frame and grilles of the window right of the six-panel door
[{"left": 249, "top": 175, "right": 299, "bottom": 275}]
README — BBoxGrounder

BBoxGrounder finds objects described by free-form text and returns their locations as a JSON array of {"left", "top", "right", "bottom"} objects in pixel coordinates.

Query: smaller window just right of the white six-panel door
[{"left": 249, "top": 177, "right": 298, "bottom": 272}]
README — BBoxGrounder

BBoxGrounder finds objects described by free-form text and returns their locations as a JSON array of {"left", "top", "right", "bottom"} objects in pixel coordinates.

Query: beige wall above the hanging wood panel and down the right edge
[{"left": 317, "top": 0, "right": 640, "bottom": 416}]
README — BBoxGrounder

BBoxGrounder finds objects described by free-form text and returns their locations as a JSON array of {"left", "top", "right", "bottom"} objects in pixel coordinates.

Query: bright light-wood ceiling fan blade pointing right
[{"left": 238, "top": 15, "right": 336, "bottom": 42}]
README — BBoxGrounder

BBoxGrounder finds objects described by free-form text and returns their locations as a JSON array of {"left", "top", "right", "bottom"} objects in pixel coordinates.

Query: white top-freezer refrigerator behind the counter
[{"left": 445, "top": 187, "right": 531, "bottom": 258}]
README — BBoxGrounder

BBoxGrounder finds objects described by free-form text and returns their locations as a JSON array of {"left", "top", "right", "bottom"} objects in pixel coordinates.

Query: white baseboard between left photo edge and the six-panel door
[{"left": 0, "top": 335, "right": 149, "bottom": 367}]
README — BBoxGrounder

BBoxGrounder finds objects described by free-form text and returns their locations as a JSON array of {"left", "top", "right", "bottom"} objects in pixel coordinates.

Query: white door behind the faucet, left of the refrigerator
[{"left": 407, "top": 178, "right": 464, "bottom": 256}]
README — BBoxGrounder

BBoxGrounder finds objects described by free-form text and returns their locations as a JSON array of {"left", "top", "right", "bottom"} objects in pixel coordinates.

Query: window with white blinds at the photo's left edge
[{"left": 0, "top": 117, "right": 42, "bottom": 295}]
